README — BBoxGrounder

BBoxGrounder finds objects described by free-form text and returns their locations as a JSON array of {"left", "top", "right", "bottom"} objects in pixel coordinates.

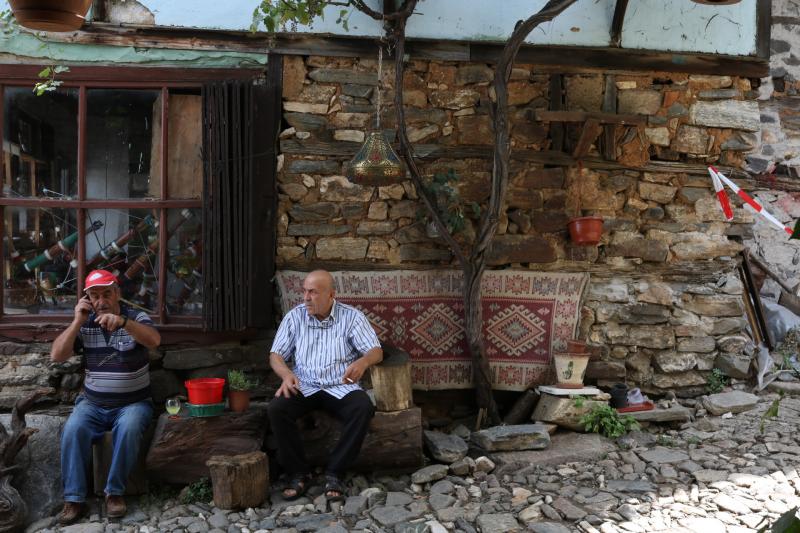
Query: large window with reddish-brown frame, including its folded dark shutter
[{"left": 0, "top": 64, "right": 279, "bottom": 331}]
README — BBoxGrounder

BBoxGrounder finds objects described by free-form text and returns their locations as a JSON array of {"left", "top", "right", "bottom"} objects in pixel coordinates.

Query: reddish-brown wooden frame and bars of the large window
[{"left": 0, "top": 65, "right": 263, "bottom": 342}]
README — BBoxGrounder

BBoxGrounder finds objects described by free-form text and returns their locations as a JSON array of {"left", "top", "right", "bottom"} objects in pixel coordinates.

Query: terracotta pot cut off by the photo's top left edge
[{"left": 8, "top": 0, "right": 92, "bottom": 31}]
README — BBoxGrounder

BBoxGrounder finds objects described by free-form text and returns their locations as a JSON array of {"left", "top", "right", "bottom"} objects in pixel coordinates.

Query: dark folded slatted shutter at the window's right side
[{"left": 202, "top": 58, "right": 281, "bottom": 331}]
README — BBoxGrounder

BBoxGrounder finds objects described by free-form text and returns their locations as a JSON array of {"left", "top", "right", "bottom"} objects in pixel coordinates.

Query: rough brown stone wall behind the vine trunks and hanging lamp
[{"left": 277, "top": 56, "right": 760, "bottom": 394}]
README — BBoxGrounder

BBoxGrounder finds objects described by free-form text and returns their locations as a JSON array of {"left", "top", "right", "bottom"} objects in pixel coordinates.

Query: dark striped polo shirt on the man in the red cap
[{"left": 75, "top": 304, "right": 153, "bottom": 408}]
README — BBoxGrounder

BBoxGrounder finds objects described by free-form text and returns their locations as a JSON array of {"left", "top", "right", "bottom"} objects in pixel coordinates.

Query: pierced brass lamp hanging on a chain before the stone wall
[{"left": 345, "top": 45, "right": 406, "bottom": 186}]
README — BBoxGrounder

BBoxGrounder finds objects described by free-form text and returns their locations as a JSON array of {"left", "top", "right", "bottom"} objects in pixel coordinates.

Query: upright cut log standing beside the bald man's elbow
[{"left": 370, "top": 345, "right": 414, "bottom": 412}]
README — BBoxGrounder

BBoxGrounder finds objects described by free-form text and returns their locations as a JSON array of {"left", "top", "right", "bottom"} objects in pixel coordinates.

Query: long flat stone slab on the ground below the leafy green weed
[{"left": 490, "top": 432, "right": 616, "bottom": 465}]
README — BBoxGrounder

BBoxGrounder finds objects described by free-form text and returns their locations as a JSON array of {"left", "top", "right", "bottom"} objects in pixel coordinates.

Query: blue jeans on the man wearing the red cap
[{"left": 61, "top": 395, "right": 153, "bottom": 502}]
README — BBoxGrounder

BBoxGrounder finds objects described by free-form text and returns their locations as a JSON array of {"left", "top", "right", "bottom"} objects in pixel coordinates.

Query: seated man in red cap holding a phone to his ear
[{"left": 50, "top": 270, "right": 161, "bottom": 525}]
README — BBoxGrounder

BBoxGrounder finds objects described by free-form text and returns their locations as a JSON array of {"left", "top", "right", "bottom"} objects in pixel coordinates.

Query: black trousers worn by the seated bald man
[{"left": 267, "top": 390, "right": 375, "bottom": 476}]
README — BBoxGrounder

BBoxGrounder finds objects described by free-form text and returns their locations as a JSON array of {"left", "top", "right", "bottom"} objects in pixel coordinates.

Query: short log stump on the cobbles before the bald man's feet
[{"left": 206, "top": 452, "right": 269, "bottom": 509}]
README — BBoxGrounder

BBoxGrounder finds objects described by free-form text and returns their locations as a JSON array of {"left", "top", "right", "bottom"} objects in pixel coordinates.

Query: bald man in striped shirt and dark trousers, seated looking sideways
[{"left": 267, "top": 270, "right": 383, "bottom": 501}]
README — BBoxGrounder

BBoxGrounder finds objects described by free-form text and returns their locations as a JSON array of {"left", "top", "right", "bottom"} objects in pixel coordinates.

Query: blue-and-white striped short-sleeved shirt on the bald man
[{"left": 270, "top": 300, "right": 381, "bottom": 399}]
